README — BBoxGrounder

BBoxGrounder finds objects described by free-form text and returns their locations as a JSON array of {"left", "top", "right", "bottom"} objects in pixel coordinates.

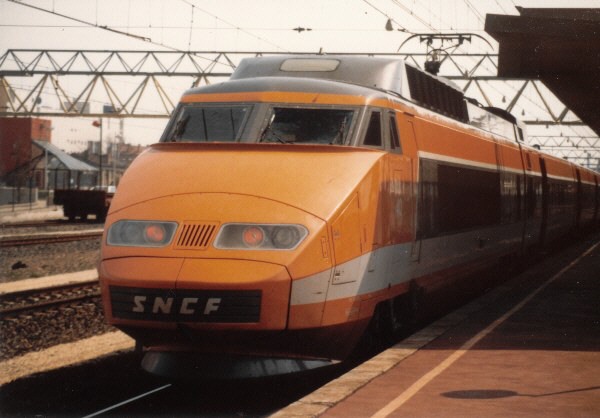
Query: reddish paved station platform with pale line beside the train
[{"left": 274, "top": 233, "right": 600, "bottom": 418}]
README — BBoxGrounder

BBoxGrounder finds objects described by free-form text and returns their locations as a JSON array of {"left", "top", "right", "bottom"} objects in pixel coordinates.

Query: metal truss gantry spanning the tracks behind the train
[{"left": 0, "top": 49, "right": 600, "bottom": 168}]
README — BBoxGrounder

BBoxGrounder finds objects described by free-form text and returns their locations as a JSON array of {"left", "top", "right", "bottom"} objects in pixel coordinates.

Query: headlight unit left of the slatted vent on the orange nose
[{"left": 107, "top": 221, "right": 177, "bottom": 247}]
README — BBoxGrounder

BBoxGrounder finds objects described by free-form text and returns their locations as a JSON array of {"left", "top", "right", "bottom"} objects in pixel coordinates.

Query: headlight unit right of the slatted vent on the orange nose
[{"left": 214, "top": 224, "right": 308, "bottom": 250}]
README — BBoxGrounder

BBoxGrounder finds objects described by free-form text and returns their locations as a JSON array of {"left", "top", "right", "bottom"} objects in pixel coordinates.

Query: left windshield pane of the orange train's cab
[{"left": 166, "top": 105, "right": 250, "bottom": 142}]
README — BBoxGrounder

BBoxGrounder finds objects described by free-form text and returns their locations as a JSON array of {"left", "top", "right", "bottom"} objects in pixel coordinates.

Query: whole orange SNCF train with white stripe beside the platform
[{"left": 99, "top": 56, "right": 600, "bottom": 377}]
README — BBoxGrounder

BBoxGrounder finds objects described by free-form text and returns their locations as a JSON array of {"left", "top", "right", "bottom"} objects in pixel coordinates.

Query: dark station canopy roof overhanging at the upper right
[{"left": 485, "top": 7, "right": 600, "bottom": 135}]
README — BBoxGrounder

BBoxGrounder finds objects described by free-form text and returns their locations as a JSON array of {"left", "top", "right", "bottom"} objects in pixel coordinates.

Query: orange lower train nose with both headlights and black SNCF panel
[{"left": 100, "top": 193, "right": 323, "bottom": 334}]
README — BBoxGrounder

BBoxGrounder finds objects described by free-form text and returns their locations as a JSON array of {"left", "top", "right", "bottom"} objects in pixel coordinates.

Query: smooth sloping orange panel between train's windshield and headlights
[{"left": 110, "top": 143, "right": 383, "bottom": 219}]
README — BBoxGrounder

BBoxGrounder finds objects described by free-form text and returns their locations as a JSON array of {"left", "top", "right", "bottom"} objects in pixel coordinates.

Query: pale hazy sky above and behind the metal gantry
[{"left": 0, "top": 0, "right": 600, "bottom": 152}]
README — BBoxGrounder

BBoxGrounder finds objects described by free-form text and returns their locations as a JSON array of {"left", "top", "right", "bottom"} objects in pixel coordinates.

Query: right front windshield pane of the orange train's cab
[{"left": 260, "top": 107, "right": 354, "bottom": 144}]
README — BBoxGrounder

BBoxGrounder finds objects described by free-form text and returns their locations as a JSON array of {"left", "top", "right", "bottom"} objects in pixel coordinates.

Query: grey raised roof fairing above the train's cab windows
[{"left": 186, "top": 55, "right": 523, "bottom": 141}]
